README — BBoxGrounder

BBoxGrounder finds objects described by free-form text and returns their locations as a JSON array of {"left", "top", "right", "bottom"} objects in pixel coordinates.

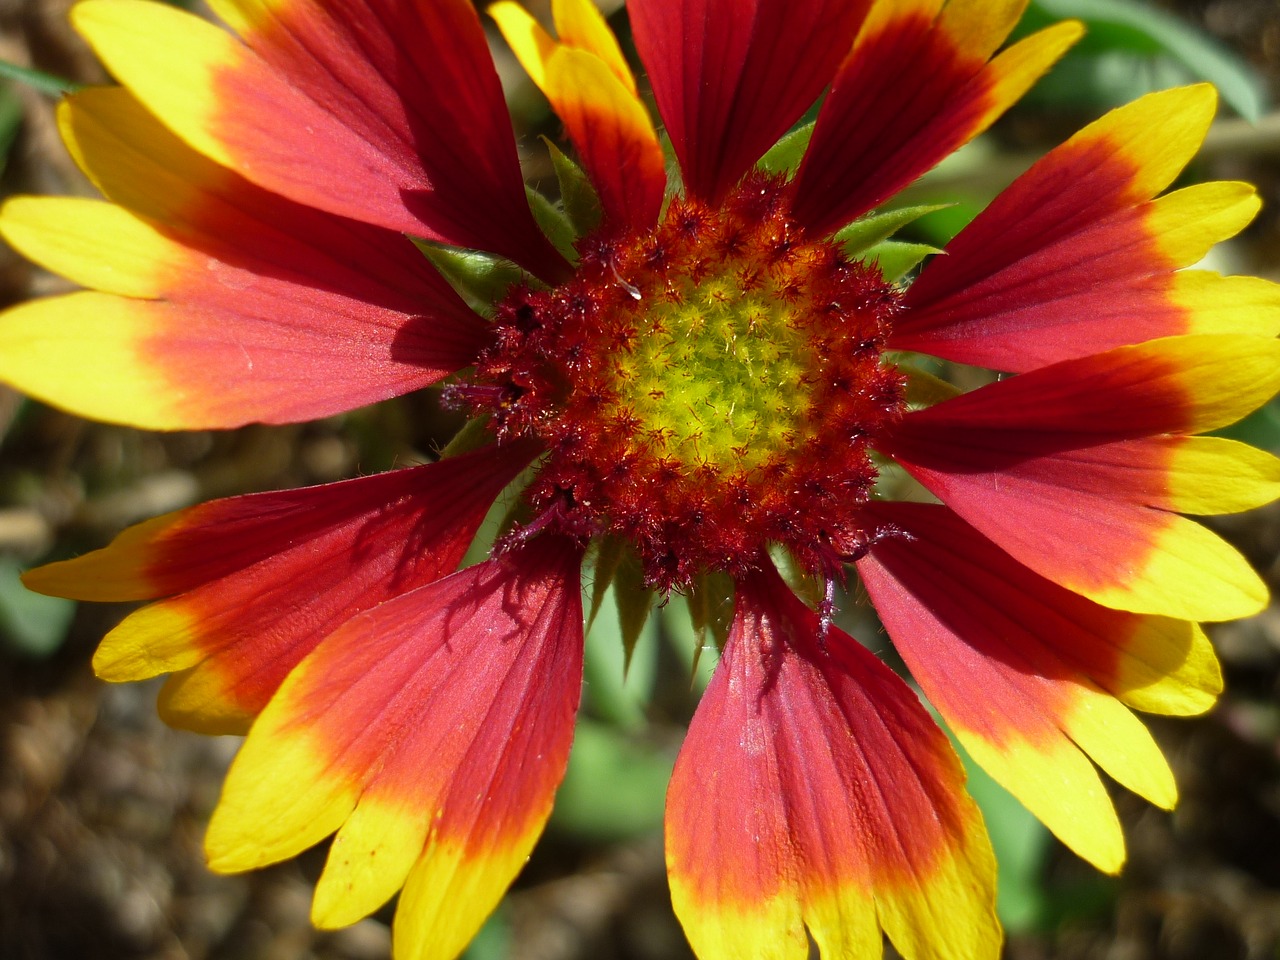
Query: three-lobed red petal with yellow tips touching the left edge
[{"left": 0, "top": 90, "right": 484, "bottom": 429}]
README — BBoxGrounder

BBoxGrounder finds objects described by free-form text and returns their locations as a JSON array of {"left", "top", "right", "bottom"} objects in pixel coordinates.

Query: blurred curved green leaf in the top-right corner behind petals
[{"left": 1019, "top": 0, "right": 1267, "bottom": 122}]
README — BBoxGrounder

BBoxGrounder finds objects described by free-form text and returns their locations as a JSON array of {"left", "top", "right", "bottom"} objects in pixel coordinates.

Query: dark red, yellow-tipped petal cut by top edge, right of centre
[{"left": 788, "top": 0, "right": 1082, "bottom": 234}]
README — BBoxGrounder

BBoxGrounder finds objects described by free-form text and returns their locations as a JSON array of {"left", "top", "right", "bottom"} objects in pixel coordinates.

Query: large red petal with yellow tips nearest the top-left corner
[{"left": 73, "top": 0, "right": 564, "bottom": 278}]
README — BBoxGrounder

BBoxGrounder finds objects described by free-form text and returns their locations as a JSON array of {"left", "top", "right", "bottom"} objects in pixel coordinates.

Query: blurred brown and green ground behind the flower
[{"left": 0, "top": 0, "right": 1280, "bottom": 960}]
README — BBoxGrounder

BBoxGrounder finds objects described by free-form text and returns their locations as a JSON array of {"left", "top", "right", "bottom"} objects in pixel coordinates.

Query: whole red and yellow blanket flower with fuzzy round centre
[{"left": 0, "top": 0, "right": 1280, "bottom": 960}]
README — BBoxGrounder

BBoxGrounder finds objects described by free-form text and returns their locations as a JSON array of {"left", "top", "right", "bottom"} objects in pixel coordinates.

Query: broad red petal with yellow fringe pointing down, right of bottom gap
[{"left": 667, "top": 567, "right": 1000, "bottom": 960}]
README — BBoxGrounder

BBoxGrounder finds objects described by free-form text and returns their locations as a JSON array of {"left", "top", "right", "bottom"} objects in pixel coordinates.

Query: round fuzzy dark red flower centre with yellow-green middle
[{"left": 472, "top": 177, "right": 904, "bottom": 590}]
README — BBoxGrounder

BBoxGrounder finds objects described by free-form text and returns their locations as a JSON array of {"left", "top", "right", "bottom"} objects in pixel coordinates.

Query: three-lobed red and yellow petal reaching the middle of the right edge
[{"left": 887, "top": 335, "right": 1280, "bottom": 620}]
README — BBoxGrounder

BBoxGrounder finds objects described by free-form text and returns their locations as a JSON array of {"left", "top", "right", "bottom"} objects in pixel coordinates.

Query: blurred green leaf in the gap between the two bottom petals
[{"left": 552, "top": 719, "right": 675, "bottom": 842}]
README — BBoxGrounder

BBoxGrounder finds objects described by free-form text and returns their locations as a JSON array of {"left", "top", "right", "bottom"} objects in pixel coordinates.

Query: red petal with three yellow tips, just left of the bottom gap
[{"left": 206, "top": 538, "right": 582, "bottom": 960}]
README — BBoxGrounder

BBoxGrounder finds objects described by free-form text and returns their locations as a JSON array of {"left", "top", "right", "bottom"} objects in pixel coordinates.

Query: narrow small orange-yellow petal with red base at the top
[{"left": 489, "top": 0, "right": 667, "bottom": 230}]
